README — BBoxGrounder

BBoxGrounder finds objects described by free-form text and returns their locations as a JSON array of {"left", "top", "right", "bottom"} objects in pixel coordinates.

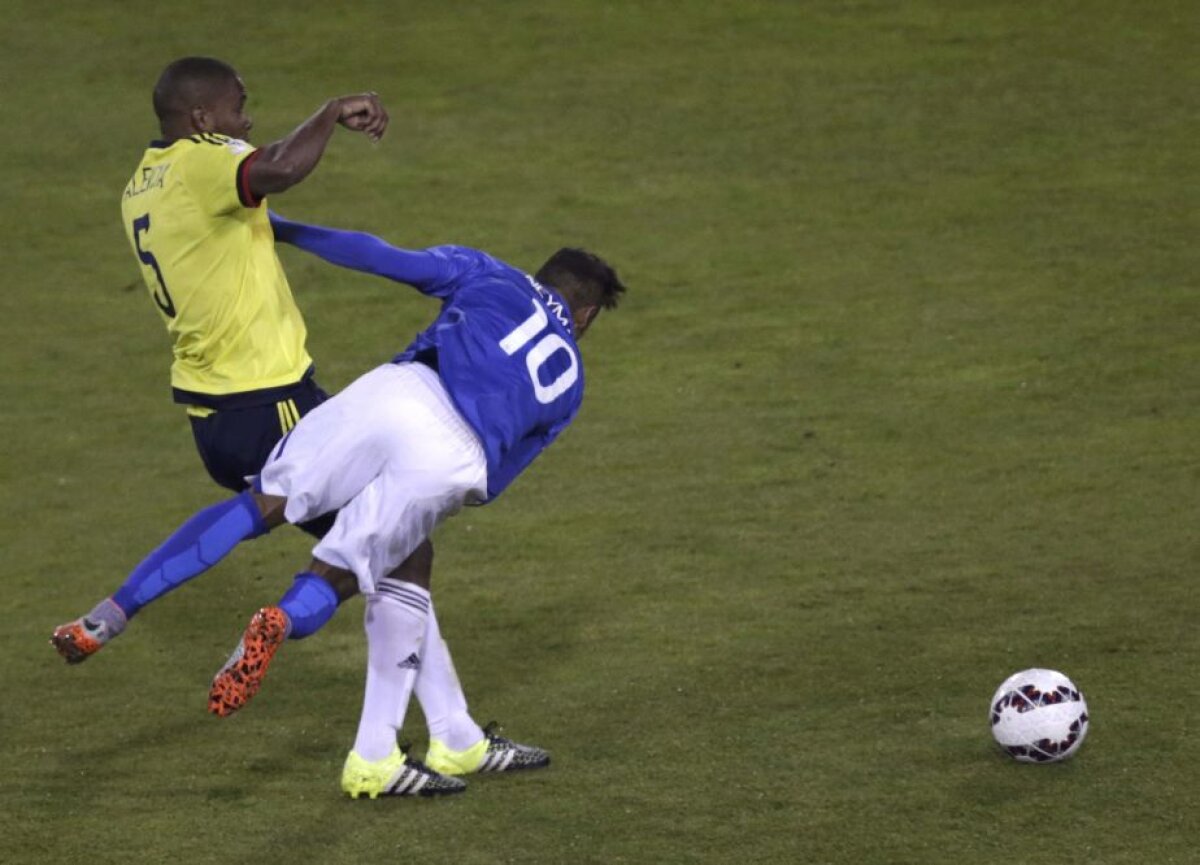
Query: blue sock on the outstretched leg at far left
[{"left": 113, "top": 492, "right": 268, "bottom": 618}]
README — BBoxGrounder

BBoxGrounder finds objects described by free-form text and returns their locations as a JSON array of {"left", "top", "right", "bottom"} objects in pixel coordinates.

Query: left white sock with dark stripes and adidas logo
[{"left": 354, "top": 579, "right": 430, "bottom": 762}]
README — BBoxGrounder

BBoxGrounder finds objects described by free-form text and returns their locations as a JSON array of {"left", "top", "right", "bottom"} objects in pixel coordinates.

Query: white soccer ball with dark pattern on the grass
[{"left": 990, "top": 669, "right": 1087, "bottom": 763}]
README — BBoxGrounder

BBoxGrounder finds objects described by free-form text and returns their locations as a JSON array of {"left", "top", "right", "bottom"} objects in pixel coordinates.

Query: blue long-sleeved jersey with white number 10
[{"left": 271, "top": 214, "right": 583, "bottom": 499}]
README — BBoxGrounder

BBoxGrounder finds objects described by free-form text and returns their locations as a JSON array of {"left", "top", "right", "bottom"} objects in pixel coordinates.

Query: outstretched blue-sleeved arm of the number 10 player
[{"left": 270, "top": 212, "right": 442, "bottom": 292}]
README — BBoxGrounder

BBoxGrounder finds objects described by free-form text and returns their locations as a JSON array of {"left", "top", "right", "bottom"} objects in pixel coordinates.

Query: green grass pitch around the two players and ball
[{"left": 0, "top": 0, "right": 1200, "bottom": 865}]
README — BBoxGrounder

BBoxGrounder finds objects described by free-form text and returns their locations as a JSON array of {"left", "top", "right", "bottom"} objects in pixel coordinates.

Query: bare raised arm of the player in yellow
[{"left": 246, "top": 94, "right": 388, "bottom": 198}]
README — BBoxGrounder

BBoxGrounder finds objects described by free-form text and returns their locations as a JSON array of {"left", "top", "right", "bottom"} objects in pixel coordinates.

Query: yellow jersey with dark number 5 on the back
[{"left": 121, "top": 133, "right": 312, "bottom": 409}]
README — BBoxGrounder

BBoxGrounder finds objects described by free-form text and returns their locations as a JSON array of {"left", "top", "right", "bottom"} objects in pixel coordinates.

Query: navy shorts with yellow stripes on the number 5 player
[{"left": 190, "top": 378, "right": 335, "bottom": 537}]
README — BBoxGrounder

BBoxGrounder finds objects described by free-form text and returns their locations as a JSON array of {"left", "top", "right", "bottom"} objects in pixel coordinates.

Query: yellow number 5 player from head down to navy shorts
[{"left": 121, "top": 58, "right": 388, "bottom": 491}]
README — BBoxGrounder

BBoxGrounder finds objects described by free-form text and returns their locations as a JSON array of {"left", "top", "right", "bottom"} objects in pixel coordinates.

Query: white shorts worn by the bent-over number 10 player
[{"left": 259, "top": 364, "right": 487, "bottom": 594}]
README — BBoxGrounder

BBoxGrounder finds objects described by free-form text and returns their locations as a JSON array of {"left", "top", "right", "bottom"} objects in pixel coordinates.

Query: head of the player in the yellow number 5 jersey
[{"left": 154, "top": 58, "right": 253, "bottom": 139}]
